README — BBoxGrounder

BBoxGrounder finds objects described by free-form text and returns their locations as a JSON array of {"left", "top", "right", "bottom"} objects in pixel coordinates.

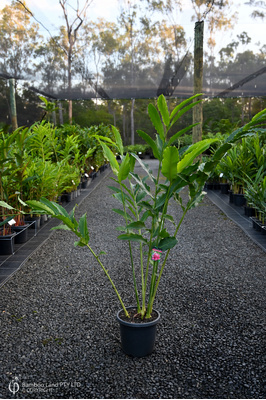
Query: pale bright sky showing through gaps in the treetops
[{"left": 0, "top": 0, "right": 266, "bottom": 52}]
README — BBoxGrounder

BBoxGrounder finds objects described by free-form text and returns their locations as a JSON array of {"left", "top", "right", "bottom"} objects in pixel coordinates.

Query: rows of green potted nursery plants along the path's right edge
[{"left": 206, "top": 131, "right": 266, "bottom": 234}]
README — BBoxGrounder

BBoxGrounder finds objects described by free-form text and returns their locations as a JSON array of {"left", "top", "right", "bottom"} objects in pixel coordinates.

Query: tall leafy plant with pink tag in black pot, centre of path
[{"left": 26, "top": 95, "right": 266, "bottom": 357}]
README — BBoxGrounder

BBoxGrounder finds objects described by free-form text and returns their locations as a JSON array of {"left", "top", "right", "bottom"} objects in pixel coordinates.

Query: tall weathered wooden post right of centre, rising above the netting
[{"left": 192, "top": 21, "right": 204, "bottom": 143}]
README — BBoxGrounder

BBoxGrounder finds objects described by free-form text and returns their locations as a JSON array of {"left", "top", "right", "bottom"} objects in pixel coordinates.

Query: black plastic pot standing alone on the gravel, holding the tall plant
[{"left": 117, "top": 307, "right": 160, "bottom": 357}]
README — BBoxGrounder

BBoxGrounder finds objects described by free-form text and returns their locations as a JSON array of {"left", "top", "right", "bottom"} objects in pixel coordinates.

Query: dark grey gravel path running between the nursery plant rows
[{"left": 0, "top": 161, "right": 266, "bottom": 398}]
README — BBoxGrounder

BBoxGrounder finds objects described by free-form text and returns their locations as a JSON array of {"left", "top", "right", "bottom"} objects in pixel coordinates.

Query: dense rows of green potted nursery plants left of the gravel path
[{"left": 0, "top": 122, "right": 113, "bottom": 254}]
